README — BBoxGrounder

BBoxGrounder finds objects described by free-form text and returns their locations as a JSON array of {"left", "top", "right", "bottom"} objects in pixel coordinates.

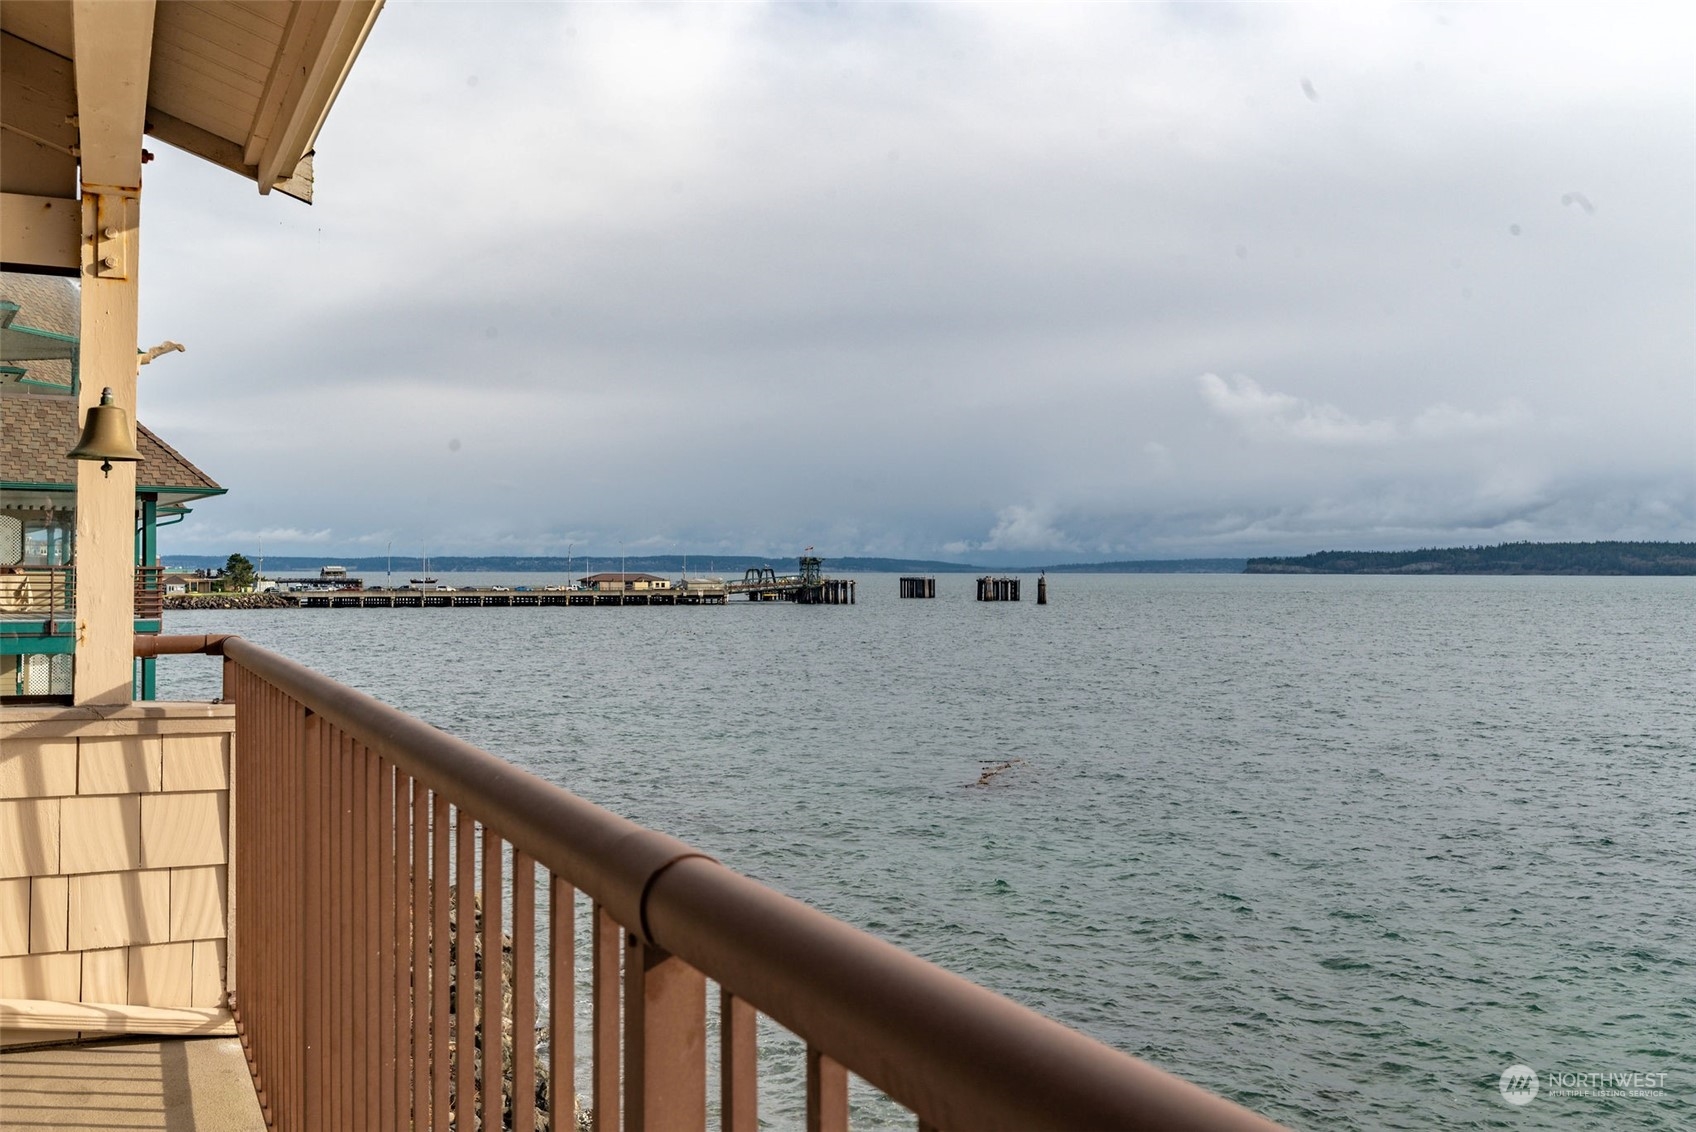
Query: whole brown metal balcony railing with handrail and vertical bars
[{"left": 137, "top": 636, "right": 1277, "bottom": 1132}]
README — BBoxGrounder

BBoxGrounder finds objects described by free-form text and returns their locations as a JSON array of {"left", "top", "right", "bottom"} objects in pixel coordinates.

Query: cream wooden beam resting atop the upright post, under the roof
[{"left": 71, "top": 0, "right": 154, "bottom": 193}]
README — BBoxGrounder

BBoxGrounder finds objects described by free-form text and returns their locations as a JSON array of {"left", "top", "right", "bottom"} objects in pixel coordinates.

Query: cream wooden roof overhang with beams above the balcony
[{"left": 0, "top": 0, "right": 382, "bottom": 272}]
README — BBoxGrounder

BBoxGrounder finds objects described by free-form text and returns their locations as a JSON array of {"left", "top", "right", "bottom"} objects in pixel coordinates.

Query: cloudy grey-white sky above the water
[{"left": 141, "top": 0, "right": 1696, "bottom": 563}]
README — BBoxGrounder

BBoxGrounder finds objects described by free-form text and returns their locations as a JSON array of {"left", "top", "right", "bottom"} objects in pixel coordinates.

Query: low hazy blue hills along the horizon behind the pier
[{"left": 161, "top": 550, "right": 1247, "bottom": 577}]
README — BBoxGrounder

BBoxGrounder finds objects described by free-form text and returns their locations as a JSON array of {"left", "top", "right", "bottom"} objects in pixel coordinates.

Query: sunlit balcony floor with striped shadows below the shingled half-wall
[{"left": 0, "top": 1037, "right": 265, "bottom": 1132}]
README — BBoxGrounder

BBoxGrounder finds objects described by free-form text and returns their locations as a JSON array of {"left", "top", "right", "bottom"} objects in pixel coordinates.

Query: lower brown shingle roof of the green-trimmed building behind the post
[{"left": 0, "top": 394, "right": 224, "bottom": 494}]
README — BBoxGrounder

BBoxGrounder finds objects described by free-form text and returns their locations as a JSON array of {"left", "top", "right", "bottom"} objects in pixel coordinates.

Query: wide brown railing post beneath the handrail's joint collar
[{"left": 624, "top": 932, "right": 707, "bottom": 1129}]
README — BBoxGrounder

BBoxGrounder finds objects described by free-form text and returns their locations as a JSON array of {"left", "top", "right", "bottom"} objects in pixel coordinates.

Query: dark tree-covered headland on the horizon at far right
[{"left": 1245, "top": 543, "right": 1696, "bottom": 574}]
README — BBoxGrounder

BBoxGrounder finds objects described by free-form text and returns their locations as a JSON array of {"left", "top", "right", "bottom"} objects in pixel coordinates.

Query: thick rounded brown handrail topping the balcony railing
[{"left": 136, "top": 636, "right": 1279, "bottom": 1130}]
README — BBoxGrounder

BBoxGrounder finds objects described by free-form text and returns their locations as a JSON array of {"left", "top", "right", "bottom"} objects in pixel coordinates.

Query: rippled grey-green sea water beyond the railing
[{"left": 159, "top": 575, "right": 1696, "bottom": 1130}]
